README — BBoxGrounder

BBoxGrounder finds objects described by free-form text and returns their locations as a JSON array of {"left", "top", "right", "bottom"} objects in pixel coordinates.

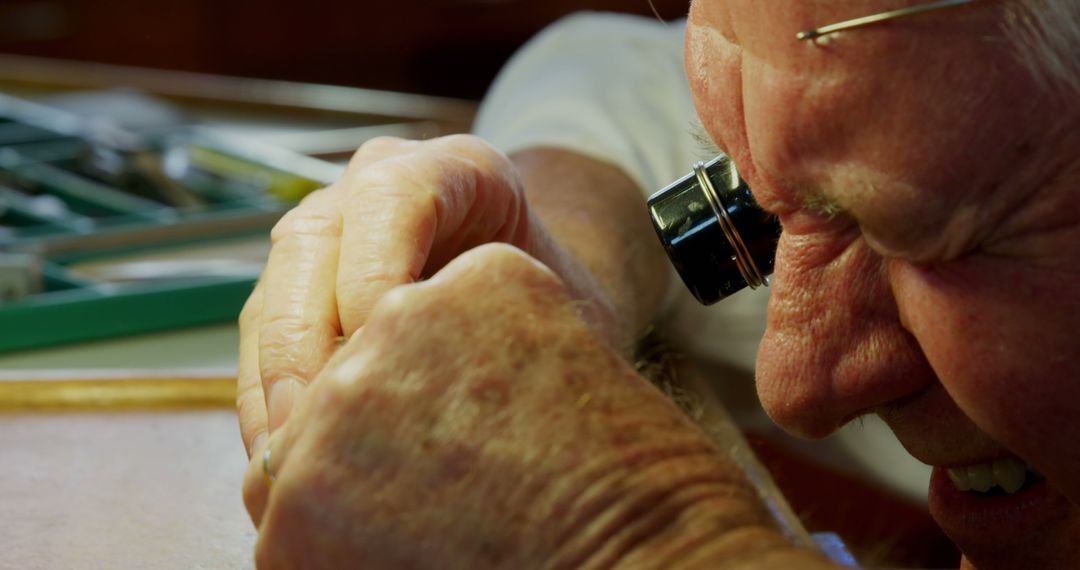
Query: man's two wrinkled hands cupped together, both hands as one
[{"left": 238, "top": 137, "right": 827, "bottom": 569}]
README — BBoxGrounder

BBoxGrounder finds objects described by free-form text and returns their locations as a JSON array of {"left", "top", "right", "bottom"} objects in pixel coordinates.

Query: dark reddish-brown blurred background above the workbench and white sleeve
[{"left": 0, "top": 0, "right": 689, "bottom": 98}]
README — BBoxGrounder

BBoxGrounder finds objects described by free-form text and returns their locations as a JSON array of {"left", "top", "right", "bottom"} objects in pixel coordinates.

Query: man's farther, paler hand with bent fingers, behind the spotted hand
[{"left": 238, "top": 136, "right": 616, "bottom": 451}]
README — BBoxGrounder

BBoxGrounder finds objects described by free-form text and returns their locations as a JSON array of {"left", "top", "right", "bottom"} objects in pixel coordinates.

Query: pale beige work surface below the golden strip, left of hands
[{"left": 0, "top": 409, "right": 255, "bottom": 570}]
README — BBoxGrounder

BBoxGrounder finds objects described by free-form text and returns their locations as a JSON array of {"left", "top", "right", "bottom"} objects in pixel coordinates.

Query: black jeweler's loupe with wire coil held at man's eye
[{"left": 648, "top": 154, "right": 780, "bottom": 304}]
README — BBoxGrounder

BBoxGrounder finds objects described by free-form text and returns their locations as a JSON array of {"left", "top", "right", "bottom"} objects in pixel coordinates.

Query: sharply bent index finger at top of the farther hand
[{"left": 337, "top": 136, "right": 526, "bottom": 336}]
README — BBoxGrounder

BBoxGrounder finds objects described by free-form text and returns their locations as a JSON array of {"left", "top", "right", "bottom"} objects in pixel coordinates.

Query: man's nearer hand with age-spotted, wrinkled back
[{"left": 245, "top": 244, "right": 816, "bottom": 568}]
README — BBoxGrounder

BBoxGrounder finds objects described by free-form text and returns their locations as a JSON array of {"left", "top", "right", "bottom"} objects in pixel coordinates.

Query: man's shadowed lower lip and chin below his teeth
[{"left": 930, "top": 469, "right": 1080, "bottom": 570}]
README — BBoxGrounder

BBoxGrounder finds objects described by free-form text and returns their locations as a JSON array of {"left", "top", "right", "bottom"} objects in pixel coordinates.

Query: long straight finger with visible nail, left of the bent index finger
[{"left": 258, "top": 188, "right": 342, "bottom": 432}]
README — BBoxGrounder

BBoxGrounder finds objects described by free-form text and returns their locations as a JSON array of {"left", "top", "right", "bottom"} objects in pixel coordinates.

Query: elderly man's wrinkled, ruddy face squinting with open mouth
[{"left": 686, "top": 0, "right": 1080, "bottom": 568}]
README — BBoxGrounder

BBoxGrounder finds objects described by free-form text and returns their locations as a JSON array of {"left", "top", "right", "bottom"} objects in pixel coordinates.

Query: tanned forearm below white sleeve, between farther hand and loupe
[{"left": 511, "top": 148, "right": 670, "bottom": 352}]
